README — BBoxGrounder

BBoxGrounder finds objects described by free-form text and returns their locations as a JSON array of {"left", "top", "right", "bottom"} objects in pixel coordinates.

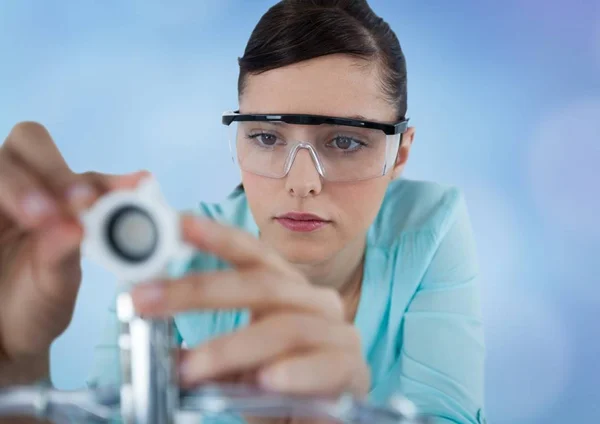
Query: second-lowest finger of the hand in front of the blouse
[{"left": 176, "top": 313, "right": 361, "bottom": 384}]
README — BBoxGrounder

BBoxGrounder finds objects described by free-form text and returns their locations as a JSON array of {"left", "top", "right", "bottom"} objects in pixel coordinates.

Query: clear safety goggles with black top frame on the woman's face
[{"left": 222, "top": 111, "right": 408, "bottom": 181}]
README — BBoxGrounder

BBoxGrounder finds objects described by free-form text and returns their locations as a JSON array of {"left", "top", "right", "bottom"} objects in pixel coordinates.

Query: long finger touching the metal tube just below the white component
[{"left": 132, "top": 268, "right": 344, "bottom": 321}]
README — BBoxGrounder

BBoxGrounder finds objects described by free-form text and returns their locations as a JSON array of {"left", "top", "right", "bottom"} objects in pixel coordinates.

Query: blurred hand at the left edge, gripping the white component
[{"left": 0, "top": 122, "right": 147, "bottom": 374}]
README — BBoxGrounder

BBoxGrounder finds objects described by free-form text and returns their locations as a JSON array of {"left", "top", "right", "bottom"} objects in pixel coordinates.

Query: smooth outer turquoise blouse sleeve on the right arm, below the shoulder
[{"left": 384, "top": 191, "right": 486, "bottom": 424}]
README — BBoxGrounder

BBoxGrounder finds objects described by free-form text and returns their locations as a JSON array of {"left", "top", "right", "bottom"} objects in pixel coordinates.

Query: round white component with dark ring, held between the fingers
[{"left": 81, "top": 177, "right": 193, "bottom": 283}]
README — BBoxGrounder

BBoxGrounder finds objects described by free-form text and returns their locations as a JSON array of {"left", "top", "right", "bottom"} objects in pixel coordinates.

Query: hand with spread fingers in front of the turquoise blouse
[{"left": 132, "top": 216, "right": 370, "bottom": 396}]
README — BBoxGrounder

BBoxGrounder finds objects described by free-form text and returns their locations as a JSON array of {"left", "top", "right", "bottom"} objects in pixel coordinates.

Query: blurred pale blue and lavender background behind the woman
[{"left": 0, "top": 0, "right": 600, "bottom": 424}]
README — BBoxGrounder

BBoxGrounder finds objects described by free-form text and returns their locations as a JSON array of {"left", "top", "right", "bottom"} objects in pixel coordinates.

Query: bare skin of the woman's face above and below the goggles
[{"left": 240, "top": 55, "right": 413, "bottom": 265}]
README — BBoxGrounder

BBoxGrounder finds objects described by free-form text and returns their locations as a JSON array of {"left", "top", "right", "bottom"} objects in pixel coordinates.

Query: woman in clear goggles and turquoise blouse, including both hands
[{"left": 0, "top": 0, "right": 484, "bottom": 423}]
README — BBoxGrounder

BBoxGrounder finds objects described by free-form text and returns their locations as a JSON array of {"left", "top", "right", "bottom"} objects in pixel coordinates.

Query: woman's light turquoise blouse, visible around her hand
[{"left": 88, "top": 179, "right": 485, "bottom": 424}]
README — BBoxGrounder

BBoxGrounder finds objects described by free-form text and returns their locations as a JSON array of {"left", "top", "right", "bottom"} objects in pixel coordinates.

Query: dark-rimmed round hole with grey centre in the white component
[{"left": 106, "top": 205, "right": 158, "bottom": 262}]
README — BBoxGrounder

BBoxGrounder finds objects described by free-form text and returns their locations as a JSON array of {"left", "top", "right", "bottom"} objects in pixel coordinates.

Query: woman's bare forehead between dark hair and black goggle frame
[{"left": 240, "top": 55, "right": 395, "bottom": 122}]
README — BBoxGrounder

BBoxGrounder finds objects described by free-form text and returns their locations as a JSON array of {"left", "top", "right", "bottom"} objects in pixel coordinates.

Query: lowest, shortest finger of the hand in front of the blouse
[{"left": 258, "top": 348, "right": 370, "bottom": 396}]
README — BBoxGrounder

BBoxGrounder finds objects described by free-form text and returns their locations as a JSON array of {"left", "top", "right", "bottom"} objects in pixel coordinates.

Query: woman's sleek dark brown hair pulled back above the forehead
[{"left": 232, "top": 0, "right": 407, "bottom": 188}]
